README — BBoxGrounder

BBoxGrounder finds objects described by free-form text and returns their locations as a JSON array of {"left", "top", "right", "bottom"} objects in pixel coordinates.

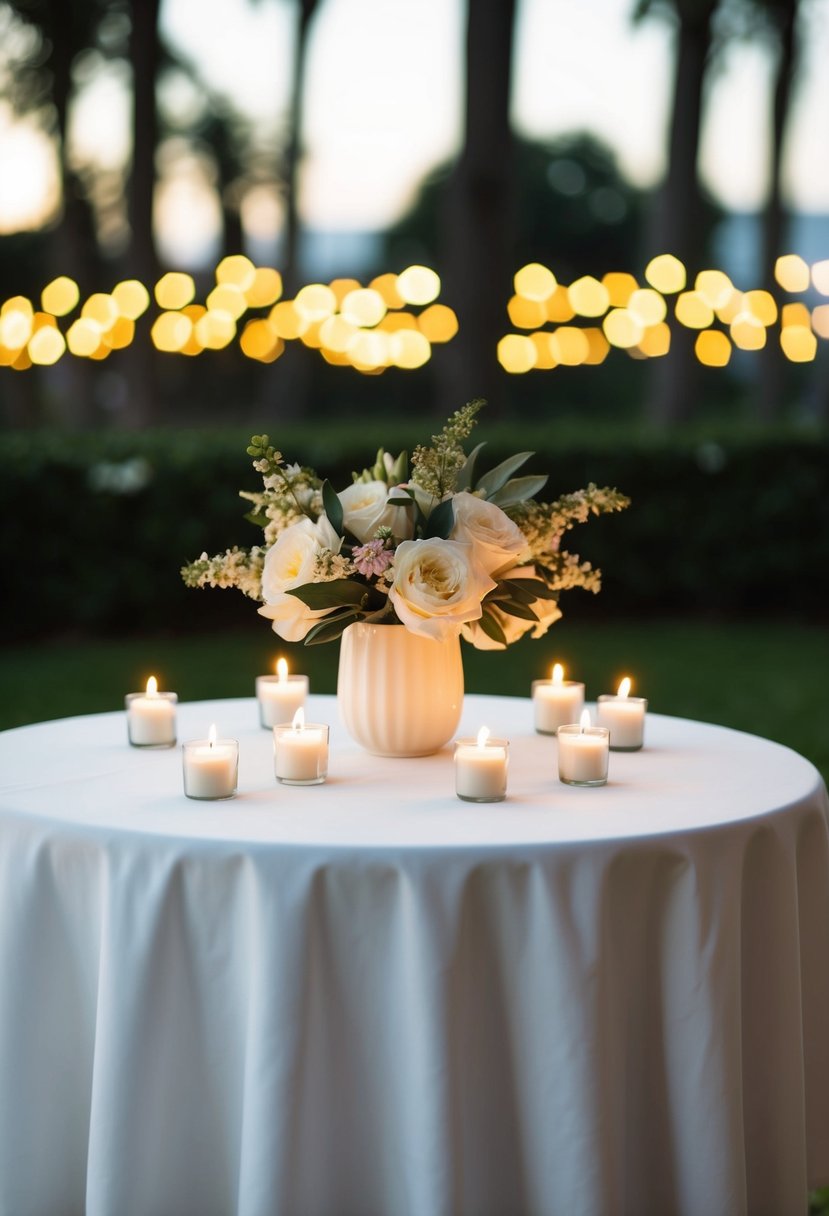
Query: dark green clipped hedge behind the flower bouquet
[{"left": 0, "top": 420, "right": 829, "bottom": 640}]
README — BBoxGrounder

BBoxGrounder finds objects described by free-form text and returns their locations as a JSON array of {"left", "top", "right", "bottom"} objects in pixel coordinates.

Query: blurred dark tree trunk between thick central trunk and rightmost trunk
[{"left": 645, "top": 0, "right": 716, "bottom": 426}]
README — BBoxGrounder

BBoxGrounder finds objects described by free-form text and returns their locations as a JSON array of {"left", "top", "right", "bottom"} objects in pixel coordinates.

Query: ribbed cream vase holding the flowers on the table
[{"left": 337, "top": 621, "right": 463, "bottom": 756}]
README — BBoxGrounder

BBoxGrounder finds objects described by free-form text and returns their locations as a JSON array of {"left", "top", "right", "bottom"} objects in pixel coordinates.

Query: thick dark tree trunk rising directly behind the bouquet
[{"left": 441, "top": 0, "right": 518, "bottom": 411}]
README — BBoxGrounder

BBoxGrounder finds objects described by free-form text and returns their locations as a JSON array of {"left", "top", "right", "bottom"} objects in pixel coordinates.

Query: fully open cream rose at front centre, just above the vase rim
[{"left": 389, "top": 540, "right": 496, "bottom": 641}]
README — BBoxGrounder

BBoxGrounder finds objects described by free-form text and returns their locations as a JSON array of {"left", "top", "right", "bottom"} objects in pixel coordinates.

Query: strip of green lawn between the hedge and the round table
[{"left": 0, "top": 618, "right": 829, "bottom": 778}]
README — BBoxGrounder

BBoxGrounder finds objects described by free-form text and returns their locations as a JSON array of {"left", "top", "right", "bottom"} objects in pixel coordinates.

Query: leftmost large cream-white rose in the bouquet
[{"left": 259, "top": 516, "right": 340, "bottom": 642}]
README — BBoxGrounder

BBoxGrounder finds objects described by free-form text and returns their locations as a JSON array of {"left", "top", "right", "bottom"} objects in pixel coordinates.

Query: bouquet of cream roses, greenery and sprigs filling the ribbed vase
[{"left": 181, "top": 401, "right": 628, "bottom": 753}]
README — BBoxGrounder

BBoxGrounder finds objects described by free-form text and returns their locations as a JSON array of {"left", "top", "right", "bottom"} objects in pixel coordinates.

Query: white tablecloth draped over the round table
[{"left": 0, "top": 697, "right": 829, "bottom": 1216}]
